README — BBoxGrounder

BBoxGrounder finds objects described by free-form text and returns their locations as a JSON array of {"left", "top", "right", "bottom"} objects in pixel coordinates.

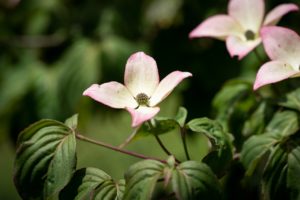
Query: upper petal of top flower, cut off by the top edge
[{"left": 228, "top": 0, "right": 265, "bottom": 33}]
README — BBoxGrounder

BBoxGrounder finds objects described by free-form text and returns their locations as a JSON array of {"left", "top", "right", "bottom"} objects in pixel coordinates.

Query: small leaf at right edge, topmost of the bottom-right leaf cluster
[{"left": 265, "top": 111, "right": 299, "bottom": 140}]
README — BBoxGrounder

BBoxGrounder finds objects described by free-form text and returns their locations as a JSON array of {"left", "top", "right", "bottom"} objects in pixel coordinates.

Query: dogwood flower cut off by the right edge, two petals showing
[{"left": 253, "top": 26, "right": 300, "bottom": 90}]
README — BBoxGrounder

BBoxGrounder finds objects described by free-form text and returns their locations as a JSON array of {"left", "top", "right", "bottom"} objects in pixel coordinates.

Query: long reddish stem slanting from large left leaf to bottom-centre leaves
[{"left": 76, "top": 133, "right": 167, "bottom": 163}]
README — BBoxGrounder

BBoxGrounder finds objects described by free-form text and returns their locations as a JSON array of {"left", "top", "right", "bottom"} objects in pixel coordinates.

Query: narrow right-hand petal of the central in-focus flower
[{"left": 149, "top": 71, "right": 192, "bottom": 106}]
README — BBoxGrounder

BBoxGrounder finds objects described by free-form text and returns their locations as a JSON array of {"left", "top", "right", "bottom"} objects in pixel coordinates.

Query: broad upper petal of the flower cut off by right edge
[{"left": 261, "top": 26, "right": 300, "bottom": 70}]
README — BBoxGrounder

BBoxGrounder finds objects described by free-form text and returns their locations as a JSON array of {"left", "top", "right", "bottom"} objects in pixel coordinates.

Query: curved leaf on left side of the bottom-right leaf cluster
[{"left": 240, "top": 134, "right": 277, "bottom": 176}]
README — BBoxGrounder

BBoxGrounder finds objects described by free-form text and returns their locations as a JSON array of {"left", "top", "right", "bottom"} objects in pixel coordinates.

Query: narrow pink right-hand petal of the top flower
[{"left": 264, "top": 3, "right": 299, "bottom": 26}]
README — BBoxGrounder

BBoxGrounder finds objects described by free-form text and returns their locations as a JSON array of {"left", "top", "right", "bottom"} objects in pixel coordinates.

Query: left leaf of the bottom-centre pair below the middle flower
[{"left": 123, "top": 160, "right": 165, "bottom": 200}]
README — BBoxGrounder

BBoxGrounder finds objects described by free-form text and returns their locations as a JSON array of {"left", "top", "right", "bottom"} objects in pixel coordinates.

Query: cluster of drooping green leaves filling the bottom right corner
[{"left": 241, "top": 108, "right": 300, "bottom": 199}]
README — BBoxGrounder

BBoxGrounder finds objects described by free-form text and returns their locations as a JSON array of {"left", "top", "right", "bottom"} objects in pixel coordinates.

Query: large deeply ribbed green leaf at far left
[{"left": 14, "top": 120, "right": 76, "bottom": 199}]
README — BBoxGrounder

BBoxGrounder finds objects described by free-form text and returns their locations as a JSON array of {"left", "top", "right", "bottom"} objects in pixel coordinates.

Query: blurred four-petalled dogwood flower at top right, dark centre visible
[{"left": 189, "top": 0, "right": 298, "bottom": 59}]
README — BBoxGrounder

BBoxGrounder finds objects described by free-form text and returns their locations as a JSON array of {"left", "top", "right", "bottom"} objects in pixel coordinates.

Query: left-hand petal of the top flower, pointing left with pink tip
[{"left": 189, "top": 15, "right": 243, "bottom": 40}]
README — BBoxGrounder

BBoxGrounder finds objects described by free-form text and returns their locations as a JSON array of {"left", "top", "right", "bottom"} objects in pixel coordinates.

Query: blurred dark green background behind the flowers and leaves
[{"left": 0, "top": 0, "right": 300, "bottom": 199}]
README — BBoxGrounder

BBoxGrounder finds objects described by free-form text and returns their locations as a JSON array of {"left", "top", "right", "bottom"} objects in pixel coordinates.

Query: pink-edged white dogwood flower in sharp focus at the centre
[{"left": 83, "top": 52, "right": 192, "bottom": 127}]
